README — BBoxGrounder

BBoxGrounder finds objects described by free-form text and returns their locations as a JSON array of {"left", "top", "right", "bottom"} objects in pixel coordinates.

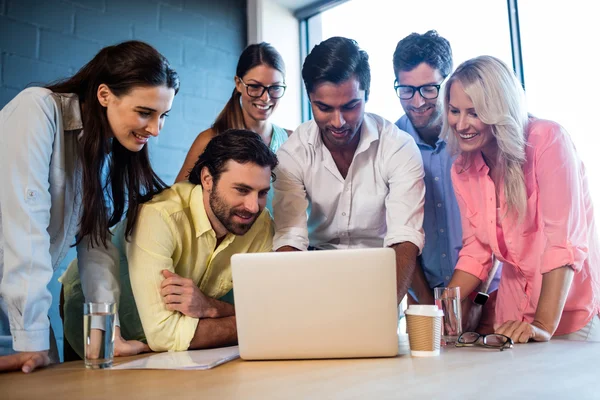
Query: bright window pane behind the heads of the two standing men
[{"left": 308, "top": 0, "right": 512, "bottom": 122}]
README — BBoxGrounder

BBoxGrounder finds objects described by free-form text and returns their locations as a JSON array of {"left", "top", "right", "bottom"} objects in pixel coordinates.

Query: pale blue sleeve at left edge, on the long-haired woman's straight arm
[{"left": 0, "top": 92, "right": 59, "bottom": 351}]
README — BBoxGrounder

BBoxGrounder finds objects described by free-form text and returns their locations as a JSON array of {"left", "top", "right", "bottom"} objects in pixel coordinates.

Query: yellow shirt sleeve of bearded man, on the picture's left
[{"left": 126, "top": 206, "right": 198, "bottom": 351}]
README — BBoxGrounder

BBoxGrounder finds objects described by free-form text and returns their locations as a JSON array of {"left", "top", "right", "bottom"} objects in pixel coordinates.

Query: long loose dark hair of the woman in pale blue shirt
[{"left": 47, "top": 41, "right": 179, "bottom": 246}]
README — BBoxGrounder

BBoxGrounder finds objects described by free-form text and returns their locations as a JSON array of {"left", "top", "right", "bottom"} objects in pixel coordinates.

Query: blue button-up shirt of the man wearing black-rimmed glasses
[{"left": 396, "top": 115, "right": 462, "bottom": 288}]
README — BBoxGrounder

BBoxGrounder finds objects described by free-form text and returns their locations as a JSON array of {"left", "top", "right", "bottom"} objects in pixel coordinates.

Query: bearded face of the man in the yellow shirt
[{"left": 201, "top": 160, "right": 271, "bottom": 237}]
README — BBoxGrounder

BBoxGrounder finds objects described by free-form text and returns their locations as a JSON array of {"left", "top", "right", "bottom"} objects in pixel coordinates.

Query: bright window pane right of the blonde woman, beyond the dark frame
[{"left": 519, "top": 0, "right": 600, "bottom": 203}]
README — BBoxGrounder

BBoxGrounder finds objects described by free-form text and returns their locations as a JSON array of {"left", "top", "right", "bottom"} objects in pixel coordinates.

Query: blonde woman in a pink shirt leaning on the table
[{"left": 442, "top": 56, "right": 600, "bottom": 343}]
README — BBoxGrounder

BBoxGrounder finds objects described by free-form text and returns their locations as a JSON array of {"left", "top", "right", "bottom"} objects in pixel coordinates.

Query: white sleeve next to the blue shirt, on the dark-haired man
[{"left": 383, "top": 136, "right": 425, "bottom": 253}]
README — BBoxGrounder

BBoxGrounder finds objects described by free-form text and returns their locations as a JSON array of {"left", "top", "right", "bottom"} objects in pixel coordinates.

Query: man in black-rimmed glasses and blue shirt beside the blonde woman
[{"left": 393, "top": 30, "right": 500, "bottom": 330}]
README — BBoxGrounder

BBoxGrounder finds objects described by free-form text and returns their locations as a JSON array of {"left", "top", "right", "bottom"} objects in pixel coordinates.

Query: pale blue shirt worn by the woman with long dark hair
[{"left": 0, "top": 87, "right": 119, "bottom": 355}]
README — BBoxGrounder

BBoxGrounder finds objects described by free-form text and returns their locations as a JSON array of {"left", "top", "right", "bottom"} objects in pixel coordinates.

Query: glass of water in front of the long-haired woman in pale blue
[{"left": 83, "top": 303, "right": 117, "bottom": 369}]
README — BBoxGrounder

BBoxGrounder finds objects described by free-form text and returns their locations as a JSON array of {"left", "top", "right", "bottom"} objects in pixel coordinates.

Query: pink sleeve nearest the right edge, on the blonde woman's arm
[{"left": 536, "top": 123, "right": 588, "bottom": 274}]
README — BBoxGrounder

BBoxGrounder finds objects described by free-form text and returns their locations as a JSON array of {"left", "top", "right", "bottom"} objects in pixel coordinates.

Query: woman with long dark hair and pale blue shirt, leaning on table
[{"left": 0, "top": 41, "right": 179, "bottom": 372}]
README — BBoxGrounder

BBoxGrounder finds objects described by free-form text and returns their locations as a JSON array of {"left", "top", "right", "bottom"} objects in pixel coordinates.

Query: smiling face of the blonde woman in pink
[{"left": 448, "top": 80, "right": 497, "bottom": 154}]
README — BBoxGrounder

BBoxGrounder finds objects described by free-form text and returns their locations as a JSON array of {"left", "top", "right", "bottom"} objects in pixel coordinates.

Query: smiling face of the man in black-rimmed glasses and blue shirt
[{"left": 396, "top": 63, "right": 444, "bottom": 131}]
